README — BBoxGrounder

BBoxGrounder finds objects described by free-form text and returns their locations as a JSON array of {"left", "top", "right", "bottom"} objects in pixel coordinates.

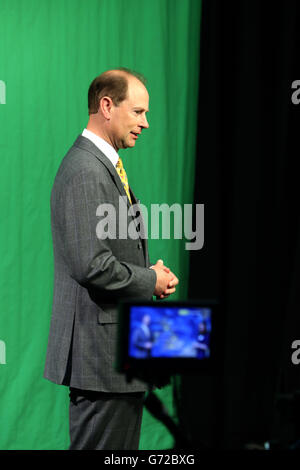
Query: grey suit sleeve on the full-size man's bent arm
[{"left": 51, "top": 170, "right": 156, "bottom": 301}]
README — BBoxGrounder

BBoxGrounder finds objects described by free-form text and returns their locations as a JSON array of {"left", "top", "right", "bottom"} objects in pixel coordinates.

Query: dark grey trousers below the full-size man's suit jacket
[{"left": 69, "top": 388, "right": 145, "bottom": 450}]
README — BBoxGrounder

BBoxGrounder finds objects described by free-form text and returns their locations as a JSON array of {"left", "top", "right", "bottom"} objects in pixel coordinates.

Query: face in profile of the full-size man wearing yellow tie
[{"left": 110, "top": 77, "right": 149, "bottom": 151}]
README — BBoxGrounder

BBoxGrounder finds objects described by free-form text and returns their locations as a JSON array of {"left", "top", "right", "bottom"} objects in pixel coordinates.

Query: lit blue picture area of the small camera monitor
[{"left": 128, "top": 305, "right": 211, "bottom": 359}]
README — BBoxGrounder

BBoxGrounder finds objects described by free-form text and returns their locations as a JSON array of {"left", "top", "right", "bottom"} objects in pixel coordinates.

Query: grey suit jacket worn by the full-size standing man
[{"left": 44, "top": 136, "right": 156, "bottom": 392}]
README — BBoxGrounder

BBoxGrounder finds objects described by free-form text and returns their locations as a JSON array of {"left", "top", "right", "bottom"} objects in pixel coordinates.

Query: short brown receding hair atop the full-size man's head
[{"left": 88, "top": 67, "right": 146, "bottom": 114}]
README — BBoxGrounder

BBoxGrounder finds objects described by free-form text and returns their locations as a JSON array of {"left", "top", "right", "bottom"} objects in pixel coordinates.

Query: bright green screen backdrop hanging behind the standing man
[{"left": 0, "top": 0, "right": 201, "bottom": 450}]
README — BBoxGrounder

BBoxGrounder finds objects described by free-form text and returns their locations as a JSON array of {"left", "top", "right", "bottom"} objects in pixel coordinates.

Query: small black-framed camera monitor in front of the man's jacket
[{"left": 118, "top": 300, "right": 217, "bottom": 373}]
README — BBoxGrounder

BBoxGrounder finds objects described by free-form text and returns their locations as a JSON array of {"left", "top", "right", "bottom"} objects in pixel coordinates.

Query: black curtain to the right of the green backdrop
[{"left": 178, "top": 0, "right": 300, "bottom": 449}]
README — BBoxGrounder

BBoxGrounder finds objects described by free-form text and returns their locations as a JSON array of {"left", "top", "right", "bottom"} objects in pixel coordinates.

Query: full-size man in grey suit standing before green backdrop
[{"left": 44, "top": 69, "right": 178, "bottom": 450}]
